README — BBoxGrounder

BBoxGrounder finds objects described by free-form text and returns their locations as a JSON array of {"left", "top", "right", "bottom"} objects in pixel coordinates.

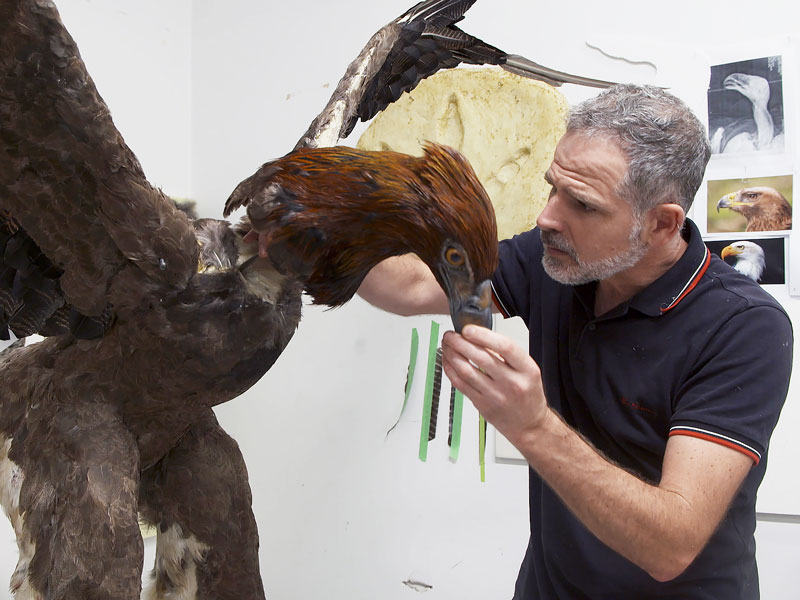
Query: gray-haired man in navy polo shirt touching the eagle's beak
[{"left": 359, "top": 85, "right": 792, "bottom": 600}]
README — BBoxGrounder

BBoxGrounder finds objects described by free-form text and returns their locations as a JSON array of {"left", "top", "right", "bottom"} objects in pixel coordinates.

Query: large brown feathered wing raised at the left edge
[{"left": 0, "top": 0, "right": 197, "bottom": 334}]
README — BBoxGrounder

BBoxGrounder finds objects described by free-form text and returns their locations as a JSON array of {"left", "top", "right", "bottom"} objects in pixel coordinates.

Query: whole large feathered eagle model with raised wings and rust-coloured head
[{"left": 0, "top": 0, "right": 612, "bottom": 600}]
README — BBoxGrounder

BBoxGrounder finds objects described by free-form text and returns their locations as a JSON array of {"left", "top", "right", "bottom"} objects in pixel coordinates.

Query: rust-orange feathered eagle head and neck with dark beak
[{"left": 225, "top": 144, "right": 498, "bottom": 331}]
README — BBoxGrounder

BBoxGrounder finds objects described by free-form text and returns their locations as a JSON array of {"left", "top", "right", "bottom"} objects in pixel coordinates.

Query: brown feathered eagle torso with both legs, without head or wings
[{"left": 0, "top": 216, "right": 302, "bottom": 598}]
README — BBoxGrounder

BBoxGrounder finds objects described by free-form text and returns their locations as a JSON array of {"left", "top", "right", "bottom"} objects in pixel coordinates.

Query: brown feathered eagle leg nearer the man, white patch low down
[{"left": 140, "top": 409, "right": 264, "bottom": 600}]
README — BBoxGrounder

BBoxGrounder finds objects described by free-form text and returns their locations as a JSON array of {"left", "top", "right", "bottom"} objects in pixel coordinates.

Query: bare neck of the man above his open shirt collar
[{"left": 594, "top": 235, "right": 689, "bottom": 317}]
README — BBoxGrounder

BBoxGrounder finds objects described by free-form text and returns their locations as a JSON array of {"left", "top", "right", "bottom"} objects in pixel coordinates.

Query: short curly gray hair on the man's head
[{"left": 567, "top": 84, "right": 711, "bottom": 217}]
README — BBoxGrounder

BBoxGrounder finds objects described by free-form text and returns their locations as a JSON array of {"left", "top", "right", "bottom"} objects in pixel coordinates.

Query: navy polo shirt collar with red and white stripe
[{"left": 629, "top": 219, "right": 711, "bottom": 317}]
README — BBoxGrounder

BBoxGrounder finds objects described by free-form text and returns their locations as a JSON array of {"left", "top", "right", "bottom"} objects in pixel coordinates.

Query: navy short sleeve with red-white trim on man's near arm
[{"left": 669, "top": 306, "right": 793, "bottom": 464}]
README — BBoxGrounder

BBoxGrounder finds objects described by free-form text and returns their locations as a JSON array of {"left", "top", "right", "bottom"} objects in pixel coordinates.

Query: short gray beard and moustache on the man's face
[{"left": 540, "top": 223, "right": 647, "bottom": 285}]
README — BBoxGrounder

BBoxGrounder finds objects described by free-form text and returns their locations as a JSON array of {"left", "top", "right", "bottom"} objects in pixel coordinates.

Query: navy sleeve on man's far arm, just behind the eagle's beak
[{"left": 492, "top": 229, "right": 542, "bottom": 324}]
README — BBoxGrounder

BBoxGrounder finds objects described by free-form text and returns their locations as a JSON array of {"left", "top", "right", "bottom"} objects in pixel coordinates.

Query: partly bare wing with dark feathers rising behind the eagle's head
[{"left": 295, "top": 0, "right": 613, "bottom": 149}]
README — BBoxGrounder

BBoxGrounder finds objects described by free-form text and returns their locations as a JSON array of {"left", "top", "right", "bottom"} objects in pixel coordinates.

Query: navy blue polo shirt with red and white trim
[{"left": 493, "top": 220, "right": 792, "bottom": 600}]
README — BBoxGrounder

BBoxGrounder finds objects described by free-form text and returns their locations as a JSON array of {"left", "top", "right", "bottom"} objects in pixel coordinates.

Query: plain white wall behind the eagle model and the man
[{"left": 0, "top": 0, "right": 800, "bottom": 600}]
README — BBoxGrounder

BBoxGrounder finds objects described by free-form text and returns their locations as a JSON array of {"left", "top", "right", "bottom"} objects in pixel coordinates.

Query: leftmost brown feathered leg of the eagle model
[{"left": 8, "top": 397, "right": 143, "bottom": 600}]
